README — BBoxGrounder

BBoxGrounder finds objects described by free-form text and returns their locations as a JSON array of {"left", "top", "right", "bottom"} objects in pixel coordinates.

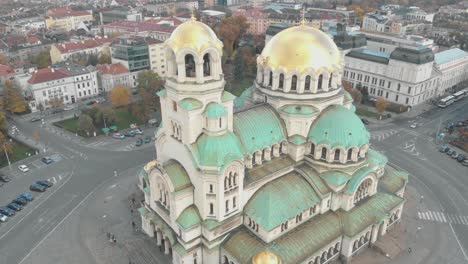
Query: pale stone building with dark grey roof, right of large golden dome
[{"left": 343, "top": 47, "right": 441, "bottom": 106}]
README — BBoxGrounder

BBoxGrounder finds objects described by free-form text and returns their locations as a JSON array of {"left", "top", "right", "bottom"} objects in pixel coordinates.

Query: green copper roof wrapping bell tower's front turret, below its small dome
[{"left": 191, "top": 131, "right": 244, "bottom": 168}]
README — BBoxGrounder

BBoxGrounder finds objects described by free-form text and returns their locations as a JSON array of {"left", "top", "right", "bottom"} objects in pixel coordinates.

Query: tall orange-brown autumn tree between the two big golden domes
[{"left": 218, "top": 16, "right": 250, "bottom": 57}]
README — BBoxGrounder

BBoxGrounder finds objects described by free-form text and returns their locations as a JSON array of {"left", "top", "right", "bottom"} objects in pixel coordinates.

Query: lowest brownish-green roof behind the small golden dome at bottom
[{"left": 223, "top": 213, "right": 340, "bottom": 264}]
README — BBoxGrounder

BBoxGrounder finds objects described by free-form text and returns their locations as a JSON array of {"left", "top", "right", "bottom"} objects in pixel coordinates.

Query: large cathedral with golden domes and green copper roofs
[{"left": 138, "top": 15, "right": 408, "bottom": 264}]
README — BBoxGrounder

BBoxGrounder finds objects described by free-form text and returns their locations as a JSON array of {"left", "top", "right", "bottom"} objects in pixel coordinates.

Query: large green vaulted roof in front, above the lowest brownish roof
[{"left": 244, "top": 172, "right": 320, "bottom": 231}]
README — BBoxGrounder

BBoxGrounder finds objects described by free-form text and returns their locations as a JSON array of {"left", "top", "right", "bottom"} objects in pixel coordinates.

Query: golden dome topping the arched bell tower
[{"left": 166, "top": 18, "right": 223, "bottom": 55}]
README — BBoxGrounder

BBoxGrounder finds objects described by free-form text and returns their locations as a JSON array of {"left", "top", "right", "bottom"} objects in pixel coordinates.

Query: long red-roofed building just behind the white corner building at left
[{"left": 50, "top": 38, "right": 112, "bottom": 63}]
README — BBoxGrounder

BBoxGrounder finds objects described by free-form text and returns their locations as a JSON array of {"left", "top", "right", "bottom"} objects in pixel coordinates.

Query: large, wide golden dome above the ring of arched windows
[{"left": 257, "top": 25, "right": 342, "bottom": 73}]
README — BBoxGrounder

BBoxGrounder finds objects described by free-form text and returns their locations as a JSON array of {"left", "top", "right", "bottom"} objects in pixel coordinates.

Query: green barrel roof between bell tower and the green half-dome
[{"left": 234, "top": 105, "right": 287, "bottom": 154}]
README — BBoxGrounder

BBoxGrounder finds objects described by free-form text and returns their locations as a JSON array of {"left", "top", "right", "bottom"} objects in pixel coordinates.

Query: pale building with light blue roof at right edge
[{"left": 434, "top": 48, "right": 468, "bottom": 95}]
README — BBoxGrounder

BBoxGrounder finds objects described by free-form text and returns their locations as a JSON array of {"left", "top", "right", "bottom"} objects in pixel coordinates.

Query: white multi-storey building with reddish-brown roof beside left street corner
[{"left": 26, "top": 63, "right": 99, "bottom": 112}]
